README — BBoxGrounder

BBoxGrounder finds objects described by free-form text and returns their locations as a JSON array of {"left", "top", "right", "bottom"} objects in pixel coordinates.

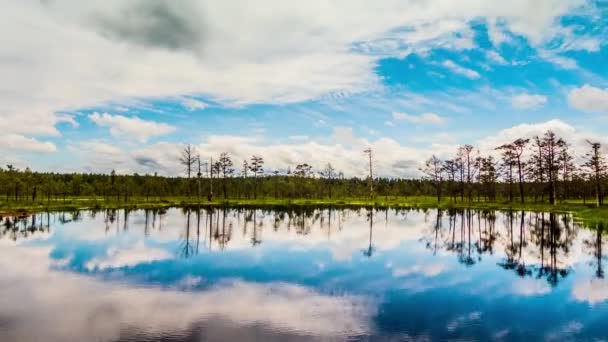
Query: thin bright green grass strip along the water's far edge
[{"left": 0, "top": 196, "right": 608, "bottom": 223}]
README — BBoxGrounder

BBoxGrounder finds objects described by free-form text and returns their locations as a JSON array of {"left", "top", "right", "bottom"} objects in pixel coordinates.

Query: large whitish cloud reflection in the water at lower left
[{"left": 0, "top": 246, "right": 377, "bottom": 342}]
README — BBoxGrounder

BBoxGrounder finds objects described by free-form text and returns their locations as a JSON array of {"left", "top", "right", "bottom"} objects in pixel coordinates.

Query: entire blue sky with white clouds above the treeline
[{"left": 0, "top": 0, "right": 608, "bottom": 177}]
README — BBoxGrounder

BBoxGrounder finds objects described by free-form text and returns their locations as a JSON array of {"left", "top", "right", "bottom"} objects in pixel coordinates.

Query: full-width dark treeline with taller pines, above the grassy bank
[{"left": 0, "top": 131, "right": 608, "bottom": 205}]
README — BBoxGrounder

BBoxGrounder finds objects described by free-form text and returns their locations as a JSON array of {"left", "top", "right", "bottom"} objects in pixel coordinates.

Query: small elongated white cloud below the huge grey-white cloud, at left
[{"left": 89, "top": 112, "right": 175, "bottom": 142}]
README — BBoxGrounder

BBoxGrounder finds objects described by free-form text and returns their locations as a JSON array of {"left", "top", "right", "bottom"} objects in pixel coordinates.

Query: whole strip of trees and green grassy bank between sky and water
[{"left": 0, "top": 131, "right": 608, "bottom": 223}]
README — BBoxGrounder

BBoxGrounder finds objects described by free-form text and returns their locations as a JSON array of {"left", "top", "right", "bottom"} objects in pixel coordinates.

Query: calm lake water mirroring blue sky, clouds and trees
[{"left": 0, "top": 209, "right": 608, "bottom": 342}]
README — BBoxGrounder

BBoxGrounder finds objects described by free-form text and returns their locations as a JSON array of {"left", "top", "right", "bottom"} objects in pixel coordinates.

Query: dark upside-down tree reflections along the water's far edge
[{"left": 0, "top": 207, "right": 606, "bottom": 286}]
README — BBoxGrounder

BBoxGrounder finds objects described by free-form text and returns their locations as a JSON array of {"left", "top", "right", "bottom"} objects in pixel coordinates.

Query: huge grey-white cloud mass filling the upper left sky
[{"left": 0, "top": 0, "right": 594, "bottom": 143}]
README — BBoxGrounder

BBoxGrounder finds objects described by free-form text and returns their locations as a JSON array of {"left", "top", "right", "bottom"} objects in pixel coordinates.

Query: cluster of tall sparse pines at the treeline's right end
[{"left": 421, "top": 131, "right": 607, "bottom": 206}]
